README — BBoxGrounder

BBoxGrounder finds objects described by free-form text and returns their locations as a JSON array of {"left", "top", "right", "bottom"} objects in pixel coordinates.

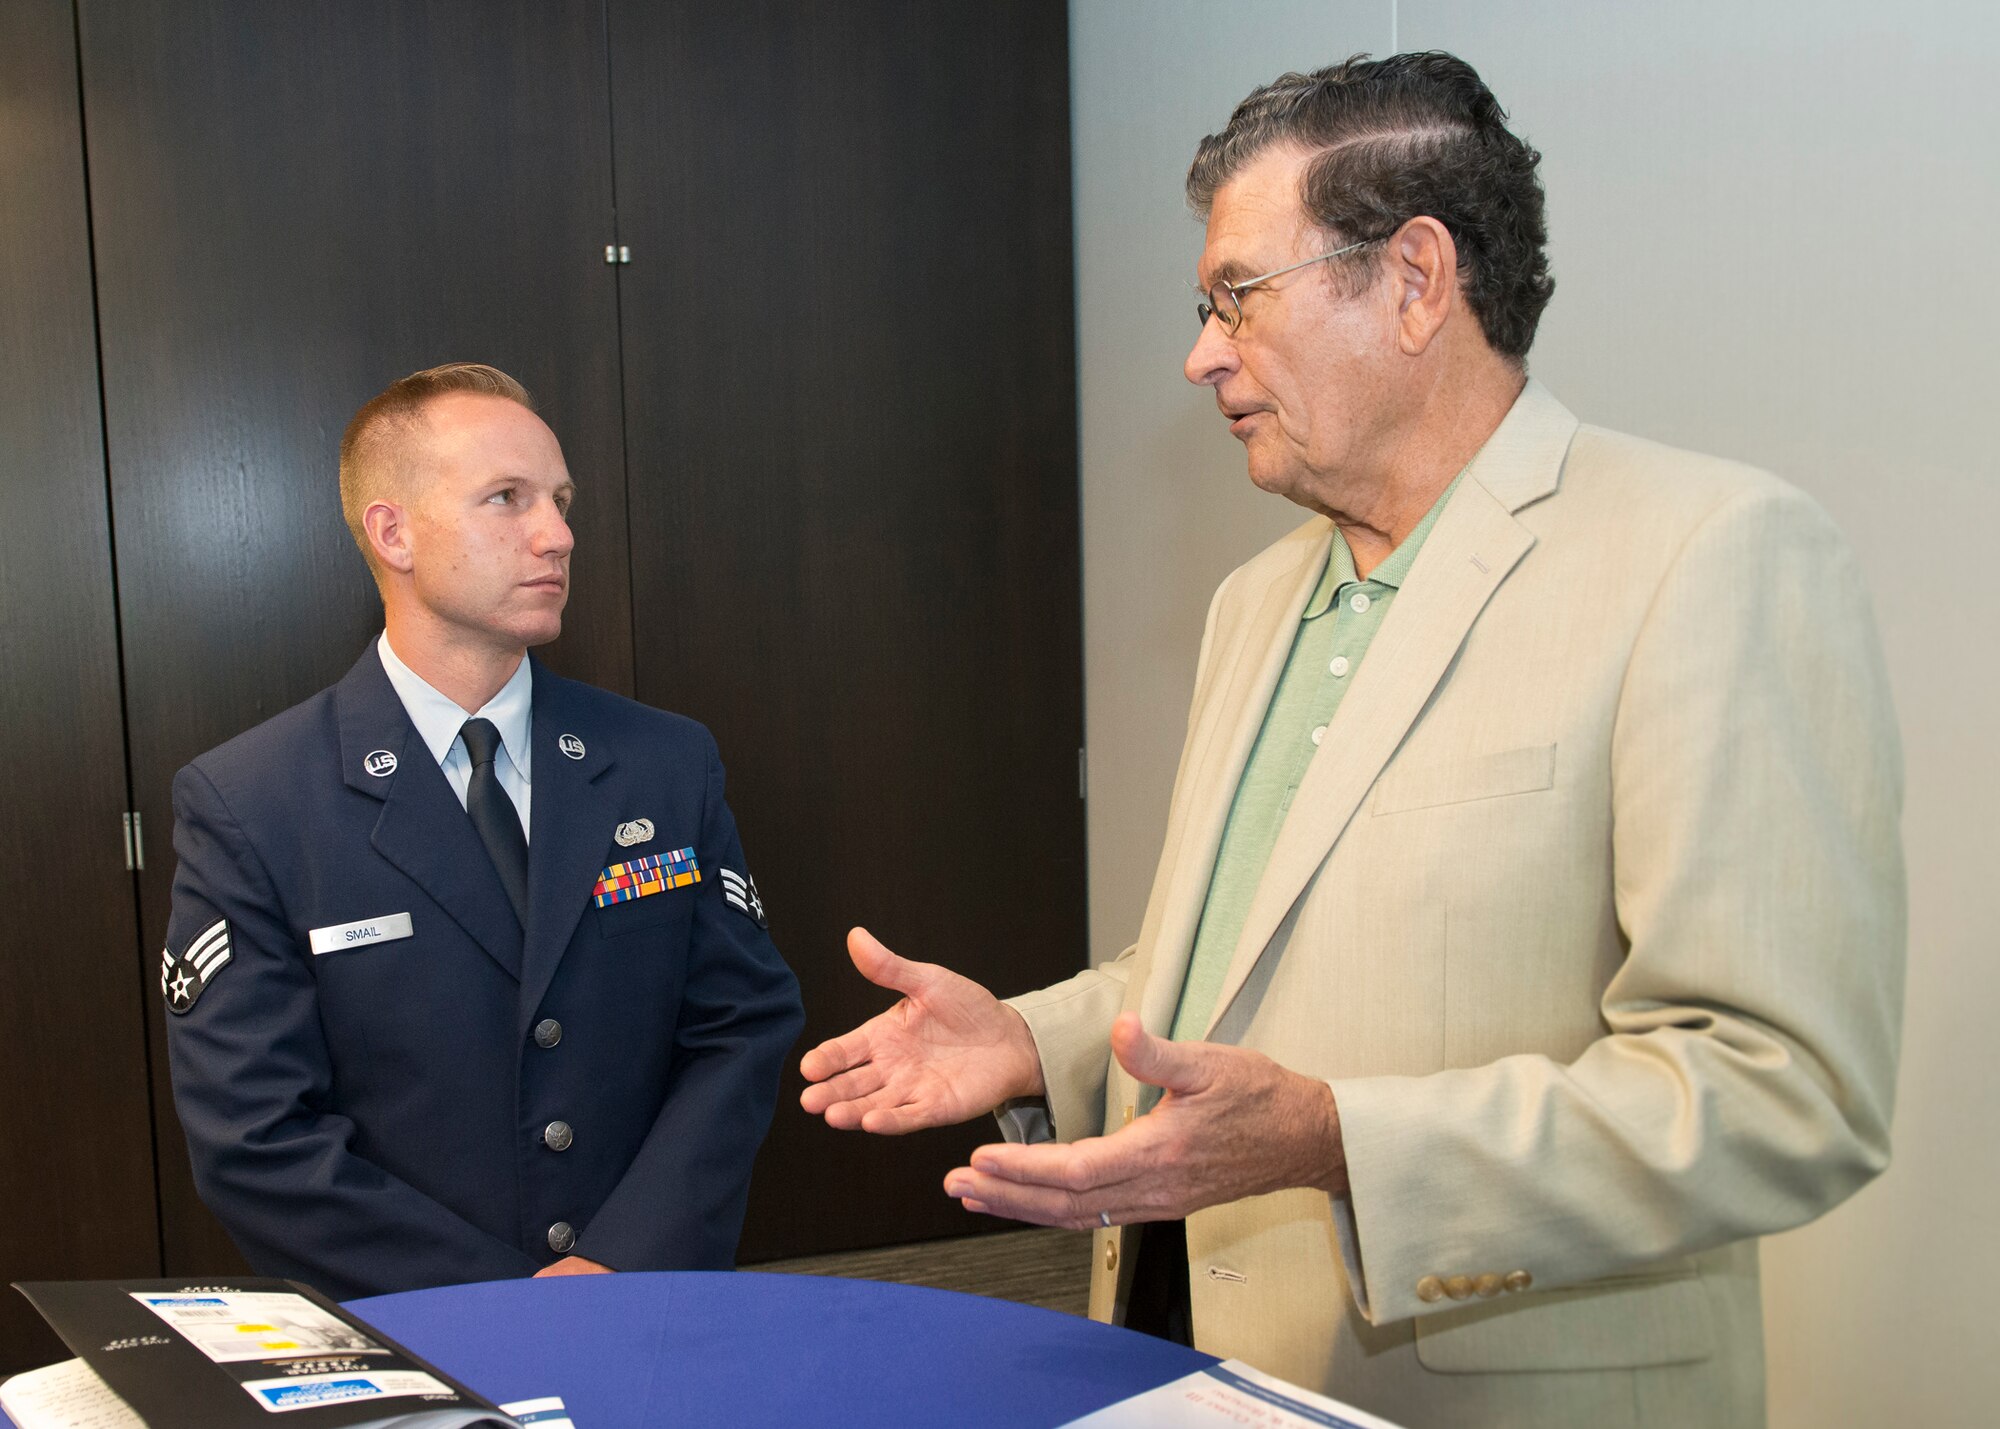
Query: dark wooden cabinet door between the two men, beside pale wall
[{"left": 610, "top": 0, "right": 1086, "bottom": 1263}]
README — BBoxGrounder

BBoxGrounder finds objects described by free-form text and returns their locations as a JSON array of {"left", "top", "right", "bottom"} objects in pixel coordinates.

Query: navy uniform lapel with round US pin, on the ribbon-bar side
[{"left": 520, "top": 660, "right": 618, "bottom": 1025}]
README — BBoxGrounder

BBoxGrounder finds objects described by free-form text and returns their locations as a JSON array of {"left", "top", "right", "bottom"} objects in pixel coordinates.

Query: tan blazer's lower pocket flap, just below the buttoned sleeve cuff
[{"left": 1414, "top": 1275, "right": 1716, "bottom": 1375}]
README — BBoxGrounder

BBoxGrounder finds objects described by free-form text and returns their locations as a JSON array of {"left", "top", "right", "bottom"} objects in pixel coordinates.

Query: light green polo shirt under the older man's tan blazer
[{"left": 1172, "top": 478, "right": 1460, "bottom": 1041}]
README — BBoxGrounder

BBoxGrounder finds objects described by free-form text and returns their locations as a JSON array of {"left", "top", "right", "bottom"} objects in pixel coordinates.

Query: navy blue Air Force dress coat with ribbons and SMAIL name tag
[{"left": 162, "top": 646, "right": 802, "bottom": 1297}]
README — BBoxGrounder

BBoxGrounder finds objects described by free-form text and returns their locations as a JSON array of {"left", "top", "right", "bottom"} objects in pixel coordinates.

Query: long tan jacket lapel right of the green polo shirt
[{"left": 1200, "top": 382, "right": 1576, "bottom": 1033}]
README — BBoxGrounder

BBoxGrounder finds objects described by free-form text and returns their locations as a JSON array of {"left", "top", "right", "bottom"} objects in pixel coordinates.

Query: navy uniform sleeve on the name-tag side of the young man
[{"left": 166, "top": 765, "right": 538, "bottom": 1299}]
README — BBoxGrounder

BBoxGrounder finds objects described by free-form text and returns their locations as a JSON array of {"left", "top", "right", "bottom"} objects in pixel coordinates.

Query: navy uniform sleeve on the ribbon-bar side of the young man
[{"left": 576, "top": 741, "right": 806, "bottom": 1271}]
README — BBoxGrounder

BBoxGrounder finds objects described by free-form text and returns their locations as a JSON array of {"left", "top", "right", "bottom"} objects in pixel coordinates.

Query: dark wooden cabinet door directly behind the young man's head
[{"left": 78, "top": 0, "right": 632, "bottom": 1273}]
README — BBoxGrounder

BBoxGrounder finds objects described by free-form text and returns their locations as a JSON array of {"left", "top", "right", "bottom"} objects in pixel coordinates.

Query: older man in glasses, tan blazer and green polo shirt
[{"left": 804, "top": 56, "right": 1904, "bottom": 1427}]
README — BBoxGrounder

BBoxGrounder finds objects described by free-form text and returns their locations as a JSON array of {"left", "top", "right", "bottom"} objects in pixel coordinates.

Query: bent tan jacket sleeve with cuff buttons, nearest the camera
[{"left": 1332, "top": 486, "right": 1904, "bottom": 1323}]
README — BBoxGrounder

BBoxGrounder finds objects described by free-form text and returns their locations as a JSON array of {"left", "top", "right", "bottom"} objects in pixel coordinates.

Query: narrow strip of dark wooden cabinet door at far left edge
[{"left": 0, "top": 0, "right": 160, "bottom": 1377}]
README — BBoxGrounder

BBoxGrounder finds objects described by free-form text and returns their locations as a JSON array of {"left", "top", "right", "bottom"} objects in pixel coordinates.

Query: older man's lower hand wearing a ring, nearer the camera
[{"left": 944, "top": 1013, "right": 1346, "bottom": 1231}]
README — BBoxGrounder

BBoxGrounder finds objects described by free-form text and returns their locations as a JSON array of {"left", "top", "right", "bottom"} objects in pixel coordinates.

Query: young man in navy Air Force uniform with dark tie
[{"left": 160, "top": 364, "right": 802, "bottom": 1297}]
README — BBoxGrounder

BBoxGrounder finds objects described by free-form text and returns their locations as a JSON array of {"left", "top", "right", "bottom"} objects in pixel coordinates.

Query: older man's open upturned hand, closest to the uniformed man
[{"left": 798, "top": 929, "right": 1042, "bottom": 1137}]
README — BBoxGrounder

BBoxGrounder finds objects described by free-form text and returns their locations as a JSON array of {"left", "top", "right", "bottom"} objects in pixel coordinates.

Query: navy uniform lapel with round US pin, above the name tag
[{"left": 334, "top": 644, "right": 522, "bottom": 977}]
